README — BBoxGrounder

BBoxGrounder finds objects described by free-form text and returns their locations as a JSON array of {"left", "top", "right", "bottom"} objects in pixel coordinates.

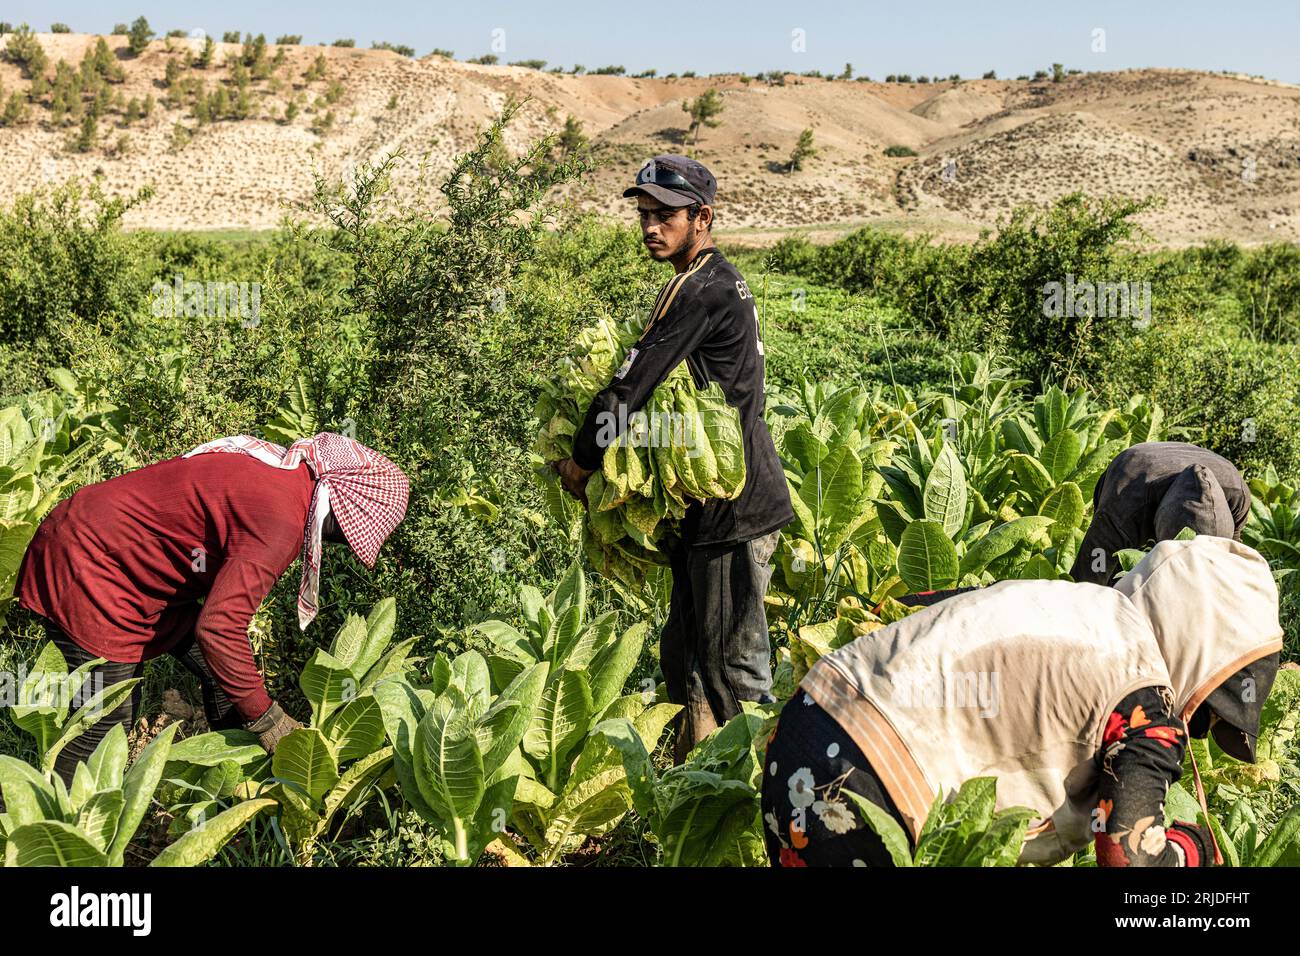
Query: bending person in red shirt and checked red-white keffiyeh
[{"left": 14, "top": 432, "right": 410, "bottom": 783}]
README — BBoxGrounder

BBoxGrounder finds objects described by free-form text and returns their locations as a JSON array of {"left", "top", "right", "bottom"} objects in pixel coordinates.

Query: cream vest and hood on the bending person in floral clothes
[{"left": 806, "top": 537, "right": 1282, "bottom": 864}]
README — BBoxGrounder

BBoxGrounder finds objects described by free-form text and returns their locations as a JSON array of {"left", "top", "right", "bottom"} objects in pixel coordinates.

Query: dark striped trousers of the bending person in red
[{"left": 44, "top": 620, "right": 243, "bottom": 786}]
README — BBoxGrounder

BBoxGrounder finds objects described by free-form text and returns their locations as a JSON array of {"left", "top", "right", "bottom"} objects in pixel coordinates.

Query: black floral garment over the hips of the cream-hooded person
[{"left": 762, "top": 689, "right": 911, "bottom": 866}]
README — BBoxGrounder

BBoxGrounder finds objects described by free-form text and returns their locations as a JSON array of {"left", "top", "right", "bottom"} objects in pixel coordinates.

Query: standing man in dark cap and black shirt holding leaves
[{"left": 556, "top": 155, "right": 794, "bottom": 762}]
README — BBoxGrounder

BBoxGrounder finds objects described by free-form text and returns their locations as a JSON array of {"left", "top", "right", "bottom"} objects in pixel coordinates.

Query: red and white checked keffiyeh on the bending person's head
[{"left": 183, "top": 432, "right": 411, "bottom": 631}]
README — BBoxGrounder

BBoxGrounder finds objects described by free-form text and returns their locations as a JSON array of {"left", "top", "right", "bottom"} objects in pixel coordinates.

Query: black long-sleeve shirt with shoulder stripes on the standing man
[{"left": 573, "top": 247, "right": 794, "bottom": 548}]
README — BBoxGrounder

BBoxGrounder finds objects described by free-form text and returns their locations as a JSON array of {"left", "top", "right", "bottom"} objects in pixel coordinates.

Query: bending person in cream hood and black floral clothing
[{"left": 762, "top": 536, "right": 1282, "bottom": 866}]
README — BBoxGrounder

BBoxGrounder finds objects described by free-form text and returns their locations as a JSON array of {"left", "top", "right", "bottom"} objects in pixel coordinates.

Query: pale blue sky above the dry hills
[{"left": 10, "top": 0, "right": 1300, "bottom": 83}]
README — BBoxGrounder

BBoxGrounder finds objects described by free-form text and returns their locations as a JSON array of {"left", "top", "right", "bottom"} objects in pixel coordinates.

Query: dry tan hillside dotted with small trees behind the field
[{"left": 0, "top": 34, "right": 1300, "bottom": 245}]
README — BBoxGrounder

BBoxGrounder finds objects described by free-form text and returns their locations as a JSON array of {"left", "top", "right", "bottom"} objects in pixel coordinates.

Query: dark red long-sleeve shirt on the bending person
[{"left": 14, "top": 454, "right": 315, "bottom": 721}]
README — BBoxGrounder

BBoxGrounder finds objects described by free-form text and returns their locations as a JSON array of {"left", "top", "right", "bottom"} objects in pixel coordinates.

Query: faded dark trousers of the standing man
[{"left": 659, "top": 531, "right": 780, "bottom": 763}]
